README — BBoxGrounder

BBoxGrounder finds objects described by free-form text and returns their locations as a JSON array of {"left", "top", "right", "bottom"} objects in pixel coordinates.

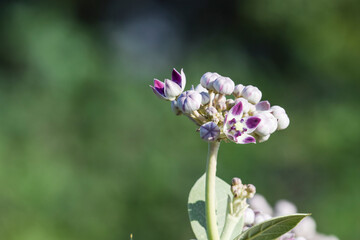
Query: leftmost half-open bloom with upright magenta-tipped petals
[{"left": 150, "top": 68, "right": 186, "bottom": 101}]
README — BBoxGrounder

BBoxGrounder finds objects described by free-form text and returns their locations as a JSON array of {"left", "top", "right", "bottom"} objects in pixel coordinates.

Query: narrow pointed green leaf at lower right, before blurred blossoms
[{"left": 234, "top": 213, "right": 310, "bottom": 240}]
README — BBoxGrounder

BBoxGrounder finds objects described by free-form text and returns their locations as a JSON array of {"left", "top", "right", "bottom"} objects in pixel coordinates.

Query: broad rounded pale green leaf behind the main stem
[{"left": 188, "top": 174, "right": 245, "bottom": 240}]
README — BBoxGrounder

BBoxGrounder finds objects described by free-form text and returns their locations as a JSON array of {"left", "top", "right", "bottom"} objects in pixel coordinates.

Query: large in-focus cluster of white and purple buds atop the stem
[{"left": 150, "top": 69, "right": 290, "bottom": 144}]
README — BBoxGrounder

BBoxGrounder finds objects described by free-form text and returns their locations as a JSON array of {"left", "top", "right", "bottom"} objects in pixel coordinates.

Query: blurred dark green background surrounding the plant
[{"left": 0, "top": 0, "right": 360, "bottom": 240}]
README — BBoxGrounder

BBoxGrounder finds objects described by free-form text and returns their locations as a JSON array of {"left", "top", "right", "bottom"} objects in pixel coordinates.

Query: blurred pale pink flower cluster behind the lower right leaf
[{"left": 243, "top": 194, "right": 338, "bottom": 240}]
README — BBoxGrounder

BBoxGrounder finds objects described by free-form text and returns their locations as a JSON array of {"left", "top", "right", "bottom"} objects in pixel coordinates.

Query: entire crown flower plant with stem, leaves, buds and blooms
[{"left": 150, "top": 69, "right": 330, "bottom": 240}]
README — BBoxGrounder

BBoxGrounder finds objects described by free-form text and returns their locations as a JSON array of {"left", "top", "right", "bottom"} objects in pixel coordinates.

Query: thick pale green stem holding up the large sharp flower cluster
[{"left": 205, "top": 141, "right": 220, "bottom": 240}]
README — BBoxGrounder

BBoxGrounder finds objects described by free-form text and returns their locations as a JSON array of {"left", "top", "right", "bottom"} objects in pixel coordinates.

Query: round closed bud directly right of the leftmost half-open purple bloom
[{"left": 177, "top": 90, "right": 202, "bottom": 113}]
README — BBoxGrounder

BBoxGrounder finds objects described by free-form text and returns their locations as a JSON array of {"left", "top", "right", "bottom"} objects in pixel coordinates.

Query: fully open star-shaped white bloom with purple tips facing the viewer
[{"left": 223, "top": 102, "right": 261, "bottom": 144}]
